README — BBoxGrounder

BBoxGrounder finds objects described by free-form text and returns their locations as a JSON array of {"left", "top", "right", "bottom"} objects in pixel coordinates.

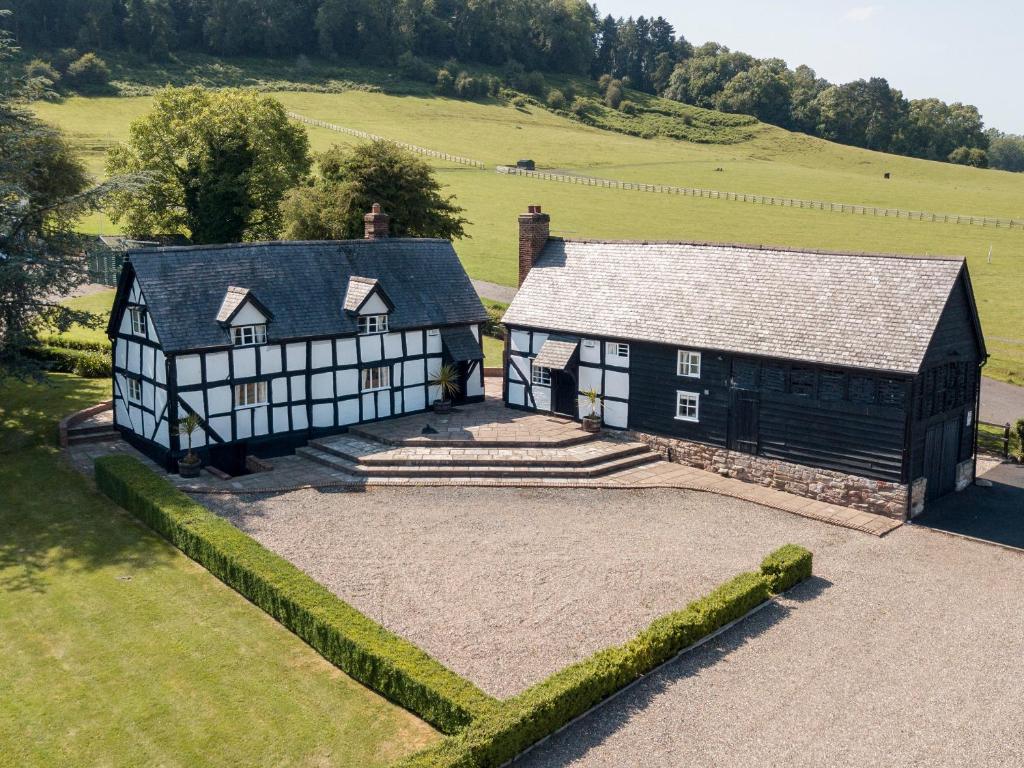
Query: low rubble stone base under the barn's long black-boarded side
[{"left": 627, "top": 431, "right": 909, "bottom": 520}]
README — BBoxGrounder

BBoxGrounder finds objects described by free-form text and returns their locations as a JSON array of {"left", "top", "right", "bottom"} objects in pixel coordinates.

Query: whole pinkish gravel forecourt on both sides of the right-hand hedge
[{"left": 203, "top": 487, "right": 1024, "bottom": 768}]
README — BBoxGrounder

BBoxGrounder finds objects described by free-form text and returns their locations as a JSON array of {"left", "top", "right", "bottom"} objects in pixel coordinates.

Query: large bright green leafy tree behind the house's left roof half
[{"left": 106, "top": 86, "right": 309, "bottom": 243}]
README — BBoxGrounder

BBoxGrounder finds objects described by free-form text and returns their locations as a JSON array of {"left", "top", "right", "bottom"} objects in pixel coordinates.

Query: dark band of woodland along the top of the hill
[{"left": 6, "top": 0, "right": 1024, "bottom": 170}]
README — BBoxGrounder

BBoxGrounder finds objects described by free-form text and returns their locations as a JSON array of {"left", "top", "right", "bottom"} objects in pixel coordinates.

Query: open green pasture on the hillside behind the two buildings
[{"left": 29, "top": 71, "right": 1024, "bottom": 382}]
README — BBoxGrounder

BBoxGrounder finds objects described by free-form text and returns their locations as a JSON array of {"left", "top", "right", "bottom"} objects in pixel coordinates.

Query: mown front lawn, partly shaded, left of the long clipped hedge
[{"left": 0, "top": 375, "right": 436, "bottom": 768}]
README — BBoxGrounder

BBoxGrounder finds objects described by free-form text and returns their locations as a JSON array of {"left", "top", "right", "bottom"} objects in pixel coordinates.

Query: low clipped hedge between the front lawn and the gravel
[{"left": 95, "top": 456, "right": 498, "bottom": 733}]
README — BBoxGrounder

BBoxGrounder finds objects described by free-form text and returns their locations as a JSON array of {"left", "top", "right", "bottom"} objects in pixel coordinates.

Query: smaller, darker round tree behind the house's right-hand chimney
[{"left": 285, "top": 141, "right": 469, "bottom": 240}]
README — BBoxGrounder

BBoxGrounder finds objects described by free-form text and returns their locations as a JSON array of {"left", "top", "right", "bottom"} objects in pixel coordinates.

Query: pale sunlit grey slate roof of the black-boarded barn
[{"left": 504, "top": 239, "right": 963, "bottom": 373}]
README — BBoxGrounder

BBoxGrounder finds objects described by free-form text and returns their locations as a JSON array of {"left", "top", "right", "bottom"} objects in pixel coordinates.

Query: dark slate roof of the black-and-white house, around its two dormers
[{"left": 129, "top": 238, "right": 487, "bottom": 352}]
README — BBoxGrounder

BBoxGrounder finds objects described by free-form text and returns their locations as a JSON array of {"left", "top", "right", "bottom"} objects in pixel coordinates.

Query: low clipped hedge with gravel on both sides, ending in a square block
[{"left": 395, "top": 545, "right": 811, "bottom": 768}]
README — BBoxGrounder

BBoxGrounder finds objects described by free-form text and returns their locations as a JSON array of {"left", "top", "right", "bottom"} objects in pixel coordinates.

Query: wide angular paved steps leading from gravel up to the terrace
[{"left": 295, "top": 435, "right": 660, "bottom": 479}]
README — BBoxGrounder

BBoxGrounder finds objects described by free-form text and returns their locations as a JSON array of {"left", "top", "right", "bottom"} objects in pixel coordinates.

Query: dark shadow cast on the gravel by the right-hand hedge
[{"left": 513, "top": 577, "right": 831, "bottom": 768}]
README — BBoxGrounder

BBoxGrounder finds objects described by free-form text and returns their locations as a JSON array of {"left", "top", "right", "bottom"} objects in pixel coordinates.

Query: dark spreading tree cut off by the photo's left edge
[{"left": 0, "top": 16, "right": 120, "bottom": 377}]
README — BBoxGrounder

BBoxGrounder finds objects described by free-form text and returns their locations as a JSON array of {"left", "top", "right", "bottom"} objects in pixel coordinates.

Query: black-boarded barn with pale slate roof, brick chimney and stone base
[{"left": 504, "top": 207, "right": 987, "bottom": 518}]
